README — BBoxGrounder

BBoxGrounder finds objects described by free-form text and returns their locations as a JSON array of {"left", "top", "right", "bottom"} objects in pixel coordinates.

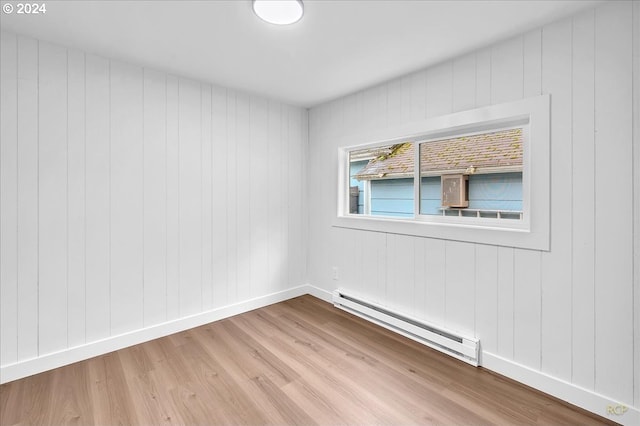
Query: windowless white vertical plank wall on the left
[{"left": 0, "top": 32, "right": 307, "bottom": 372}]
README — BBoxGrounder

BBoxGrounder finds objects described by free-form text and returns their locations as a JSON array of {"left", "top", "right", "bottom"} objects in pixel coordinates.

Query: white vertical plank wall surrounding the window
[{"left": 308, "top": 2, "right": 640, "bottom": 413}]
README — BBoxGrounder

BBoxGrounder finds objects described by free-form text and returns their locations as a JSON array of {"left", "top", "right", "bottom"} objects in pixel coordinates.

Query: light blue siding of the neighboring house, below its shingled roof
[{"left": 368, "top": 173, "right": 522, "bottom": 217}]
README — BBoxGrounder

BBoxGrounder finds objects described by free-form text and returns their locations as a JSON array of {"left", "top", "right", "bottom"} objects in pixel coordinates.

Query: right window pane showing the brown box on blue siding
[{"left": 420, "top": 128, "right": 523, "bottom": 219}]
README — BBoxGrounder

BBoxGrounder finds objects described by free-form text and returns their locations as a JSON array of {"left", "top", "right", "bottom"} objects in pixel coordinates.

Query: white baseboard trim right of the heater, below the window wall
[{"left": 481, "top": 352, "right": 640, "bottom": 425}]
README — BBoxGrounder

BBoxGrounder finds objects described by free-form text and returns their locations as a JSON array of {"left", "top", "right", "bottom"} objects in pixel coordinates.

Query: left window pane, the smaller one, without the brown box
[{"left": 349, "top": 142, "right": 414, "bottom": 217}]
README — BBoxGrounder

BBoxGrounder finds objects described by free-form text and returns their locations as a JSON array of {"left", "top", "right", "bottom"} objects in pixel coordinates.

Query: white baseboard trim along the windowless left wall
[{"left": 0, "top": 285, "right": 310, "bottom": 384}]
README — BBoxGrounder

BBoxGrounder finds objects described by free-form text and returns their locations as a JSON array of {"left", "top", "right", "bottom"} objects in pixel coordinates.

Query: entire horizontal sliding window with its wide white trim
[{"left": 334, "top": 96, "right": 549, "bottom": 250}]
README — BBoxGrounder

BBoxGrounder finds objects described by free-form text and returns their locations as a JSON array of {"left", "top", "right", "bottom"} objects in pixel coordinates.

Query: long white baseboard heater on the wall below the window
[{"left": 333, "top": 290, "right": 480, "bottom": 367}]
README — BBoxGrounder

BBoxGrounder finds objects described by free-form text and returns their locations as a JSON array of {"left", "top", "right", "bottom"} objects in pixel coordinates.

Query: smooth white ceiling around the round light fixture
[{"left": 0, "top": 0, "right": 600, "bottom": 107}]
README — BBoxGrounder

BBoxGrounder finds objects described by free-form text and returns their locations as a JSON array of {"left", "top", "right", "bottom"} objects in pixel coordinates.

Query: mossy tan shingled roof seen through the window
[{"left": 351, "top": 128, "right": 523, "bottom": 180}]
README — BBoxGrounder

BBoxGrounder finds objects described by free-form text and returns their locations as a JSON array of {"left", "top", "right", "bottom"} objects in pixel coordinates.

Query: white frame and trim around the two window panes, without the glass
[{"left": 333, "top": 95, "right": 550, "bottom": 251}]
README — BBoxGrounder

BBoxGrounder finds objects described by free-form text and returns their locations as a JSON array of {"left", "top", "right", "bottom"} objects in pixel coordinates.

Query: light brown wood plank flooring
[{"left": 0, "top": 296, "right": 613, "bottom": 426}]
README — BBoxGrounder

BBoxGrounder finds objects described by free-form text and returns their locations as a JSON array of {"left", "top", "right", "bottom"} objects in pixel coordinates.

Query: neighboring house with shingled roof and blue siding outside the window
[{"left": 350, "top": 128, "right": 523, "bottom": 219}]
